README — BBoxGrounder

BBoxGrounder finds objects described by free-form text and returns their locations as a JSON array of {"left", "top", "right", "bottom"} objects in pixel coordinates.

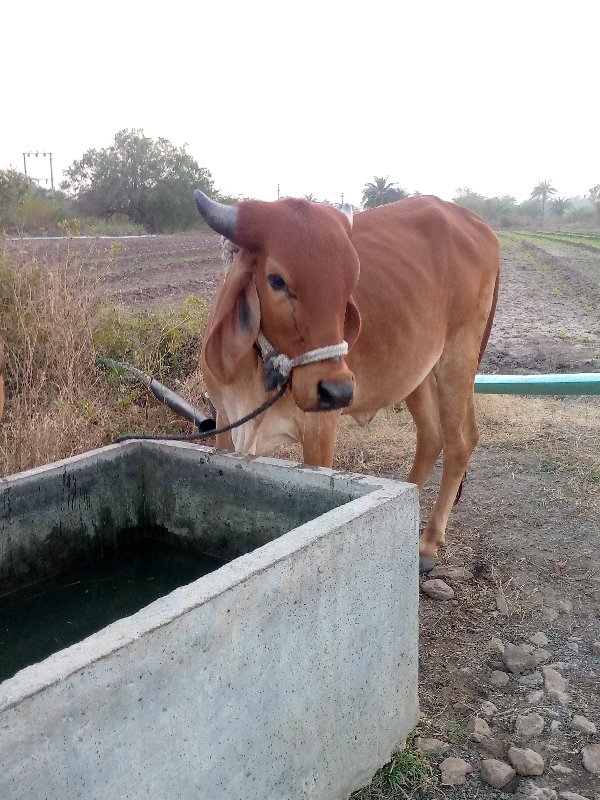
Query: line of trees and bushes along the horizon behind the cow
[{"left": 0, "top": 129, "right": 600, "bottom": 234}]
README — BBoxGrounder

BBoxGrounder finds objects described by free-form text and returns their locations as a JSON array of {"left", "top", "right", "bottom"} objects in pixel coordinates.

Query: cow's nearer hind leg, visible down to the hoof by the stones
[{"left": 419, "top": 348, "right": 479, "bottom": 556}]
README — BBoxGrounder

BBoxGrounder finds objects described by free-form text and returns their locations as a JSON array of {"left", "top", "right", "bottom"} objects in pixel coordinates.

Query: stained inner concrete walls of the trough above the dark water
[{"left": 0, "top": 442, "right": 356, "bottom": 596}]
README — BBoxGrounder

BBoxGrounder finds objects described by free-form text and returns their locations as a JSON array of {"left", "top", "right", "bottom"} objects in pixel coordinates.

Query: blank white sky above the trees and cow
[{"left": 0, "top": 0, "right": 600, "bottom": 204}]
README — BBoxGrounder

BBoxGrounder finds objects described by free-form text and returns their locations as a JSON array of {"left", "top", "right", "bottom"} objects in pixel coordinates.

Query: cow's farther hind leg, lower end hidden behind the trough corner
[{"left": 406, "top": 372, "right": 443, "bottom": 490}]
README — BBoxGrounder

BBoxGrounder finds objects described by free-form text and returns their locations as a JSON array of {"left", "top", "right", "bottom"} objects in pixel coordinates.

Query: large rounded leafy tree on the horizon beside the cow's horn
[{"left": 62, "top": 129, "right": 214, "bottom": 233}]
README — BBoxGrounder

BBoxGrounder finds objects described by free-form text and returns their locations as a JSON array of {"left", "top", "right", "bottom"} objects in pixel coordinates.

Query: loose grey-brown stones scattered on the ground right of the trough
[{"left": 415, "top": 564, "right": 600, "bottom": 800}]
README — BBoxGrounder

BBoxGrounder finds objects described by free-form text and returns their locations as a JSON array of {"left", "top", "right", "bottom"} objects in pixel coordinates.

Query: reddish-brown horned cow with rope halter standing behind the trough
[{"left": 196, "top": 192, "right": 499, "bottom": 556}]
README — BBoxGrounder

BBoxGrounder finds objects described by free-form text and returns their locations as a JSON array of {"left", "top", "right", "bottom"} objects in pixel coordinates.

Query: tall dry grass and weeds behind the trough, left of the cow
[{"left": 0, "top": 248, "right": 210, "bottom": 475}]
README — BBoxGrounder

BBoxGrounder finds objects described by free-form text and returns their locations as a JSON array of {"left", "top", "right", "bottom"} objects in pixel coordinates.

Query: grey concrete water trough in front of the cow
[{"left": 0, "top": 442, "right": 418, "bottom": 800}]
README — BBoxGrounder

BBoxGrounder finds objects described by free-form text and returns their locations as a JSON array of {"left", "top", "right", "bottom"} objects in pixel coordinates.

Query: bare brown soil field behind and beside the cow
[{"left": 5, "top": 228, "right": 600, "bottom": 800}]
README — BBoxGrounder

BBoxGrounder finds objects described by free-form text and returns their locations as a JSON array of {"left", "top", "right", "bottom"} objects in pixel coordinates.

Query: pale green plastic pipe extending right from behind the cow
[{"left": 475, "top": 372, "right": 600, "bottom": 395}]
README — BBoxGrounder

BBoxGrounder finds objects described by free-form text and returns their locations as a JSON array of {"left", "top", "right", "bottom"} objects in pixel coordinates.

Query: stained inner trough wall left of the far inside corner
[{"left": 0, "top": 444, "right": 144, "bottom": 595}]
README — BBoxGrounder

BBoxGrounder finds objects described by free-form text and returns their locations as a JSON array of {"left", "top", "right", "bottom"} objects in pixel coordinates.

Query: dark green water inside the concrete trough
[{"left": 0, "top": 539, "right": 226, "bottom": 681}]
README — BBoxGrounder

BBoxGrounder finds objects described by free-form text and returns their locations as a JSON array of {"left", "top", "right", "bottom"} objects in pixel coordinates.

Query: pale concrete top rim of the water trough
[{"left": 0, "top": 442, "right": 418, "bottom": 713}]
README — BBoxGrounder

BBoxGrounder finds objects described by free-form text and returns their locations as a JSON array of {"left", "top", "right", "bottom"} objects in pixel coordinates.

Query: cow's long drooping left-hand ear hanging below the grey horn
[{"left": 204, "top": 250, "right": 260, "bottom": 383}]
